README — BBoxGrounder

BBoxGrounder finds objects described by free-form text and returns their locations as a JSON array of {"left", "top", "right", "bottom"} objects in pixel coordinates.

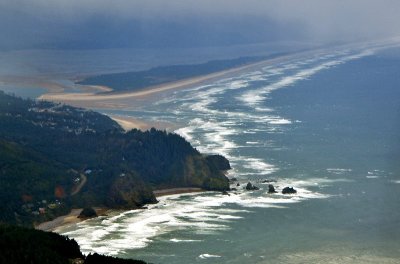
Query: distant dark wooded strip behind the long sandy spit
[{"left": 78, "top": 54, "right": 276, "bottom": 91}]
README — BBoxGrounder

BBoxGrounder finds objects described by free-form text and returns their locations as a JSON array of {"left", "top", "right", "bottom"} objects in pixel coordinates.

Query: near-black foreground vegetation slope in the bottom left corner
[{"left": 0, "top": 224, "right": 146, "bottom": 264}]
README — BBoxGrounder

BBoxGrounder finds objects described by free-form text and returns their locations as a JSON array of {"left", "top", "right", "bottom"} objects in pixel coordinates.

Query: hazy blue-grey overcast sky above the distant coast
[{"left": 0, "top": 0, "right": 400, "bottom": 49}]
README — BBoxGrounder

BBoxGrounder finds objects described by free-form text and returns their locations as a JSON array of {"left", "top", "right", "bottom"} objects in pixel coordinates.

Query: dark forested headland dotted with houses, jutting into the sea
[{"left": 0, "top": 91, "right": 230, "bottom": 225}]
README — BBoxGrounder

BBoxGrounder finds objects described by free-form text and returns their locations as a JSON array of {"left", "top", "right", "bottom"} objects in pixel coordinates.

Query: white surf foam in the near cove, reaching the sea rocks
[{"left": 64, "top": 175, "right": 338, "bottom": 255}]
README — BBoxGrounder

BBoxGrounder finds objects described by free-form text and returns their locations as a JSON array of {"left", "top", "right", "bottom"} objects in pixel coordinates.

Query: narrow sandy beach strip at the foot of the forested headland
[{"left": 34, "top": 187, "right": 206, "bottom": 233}]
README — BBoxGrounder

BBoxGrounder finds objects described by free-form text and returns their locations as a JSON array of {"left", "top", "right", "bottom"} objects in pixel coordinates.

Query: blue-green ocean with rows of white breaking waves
[{"left": 54, "top": 44, "right": 400, "bottom": 263}]
